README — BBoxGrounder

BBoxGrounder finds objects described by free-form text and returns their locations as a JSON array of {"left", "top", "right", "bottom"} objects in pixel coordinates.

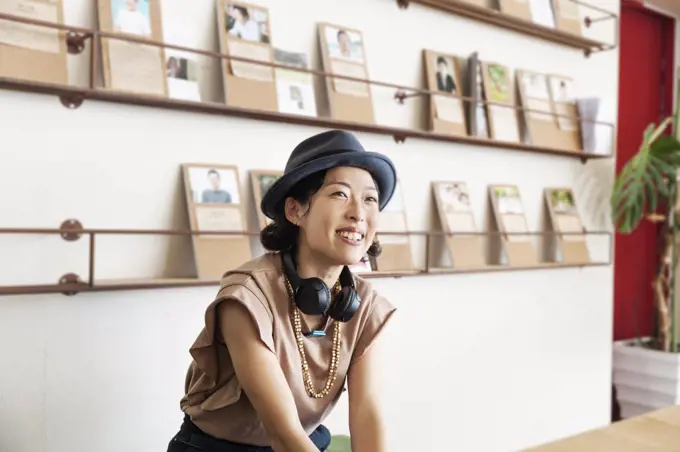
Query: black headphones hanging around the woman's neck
[{"left": 281, "top": 251, "right": 361, "bottom": 322}]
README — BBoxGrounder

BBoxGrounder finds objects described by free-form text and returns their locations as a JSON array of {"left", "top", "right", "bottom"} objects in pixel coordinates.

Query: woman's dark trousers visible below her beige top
[{"left": 180, "top": 414, "right": 331, "bottom": 452}]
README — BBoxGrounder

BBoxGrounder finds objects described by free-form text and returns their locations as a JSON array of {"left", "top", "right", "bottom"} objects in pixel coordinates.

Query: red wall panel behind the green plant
[{"left": 614, "top": 0, "right": 680, "bottom": 340}]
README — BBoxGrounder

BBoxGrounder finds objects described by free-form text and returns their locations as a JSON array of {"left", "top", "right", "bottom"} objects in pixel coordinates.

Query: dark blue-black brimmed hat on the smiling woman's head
[{"left": 260, "top": 130, "right": 397, "bottom": 219}]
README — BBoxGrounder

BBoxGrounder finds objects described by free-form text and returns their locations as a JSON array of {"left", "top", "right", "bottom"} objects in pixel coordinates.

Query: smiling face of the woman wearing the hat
[{"left": 289, "top": 167, "right": 380, "bottom": 265}]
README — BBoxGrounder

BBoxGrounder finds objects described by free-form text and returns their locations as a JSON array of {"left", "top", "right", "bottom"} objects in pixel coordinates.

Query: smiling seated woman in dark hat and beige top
[{"left": 168, "top": 131, "right": 397, "bottom": 452}]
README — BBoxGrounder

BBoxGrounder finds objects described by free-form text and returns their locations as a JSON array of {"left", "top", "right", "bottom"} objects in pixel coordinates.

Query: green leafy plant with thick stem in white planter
[{"left": 611, "top": 113, "right": 680, "bottom": 352}]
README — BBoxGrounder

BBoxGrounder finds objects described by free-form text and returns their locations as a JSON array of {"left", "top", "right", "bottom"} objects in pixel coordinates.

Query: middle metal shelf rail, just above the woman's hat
[{"left": 0, "top": 13, "right": 615, "bottom": 163}]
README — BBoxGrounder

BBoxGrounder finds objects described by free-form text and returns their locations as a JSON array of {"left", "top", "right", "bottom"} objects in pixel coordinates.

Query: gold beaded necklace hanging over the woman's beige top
[{"left": 284, "top": 273, "right": 340, "bottom": 399}]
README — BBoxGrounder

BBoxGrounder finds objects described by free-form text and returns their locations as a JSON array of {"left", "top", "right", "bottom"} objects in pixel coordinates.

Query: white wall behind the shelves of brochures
[{"left": 0, "top": 0, "right": 619, "bottom": 452}]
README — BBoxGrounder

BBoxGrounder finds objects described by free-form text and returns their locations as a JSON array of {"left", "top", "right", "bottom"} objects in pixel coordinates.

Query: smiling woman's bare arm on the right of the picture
[{"left": 347, "top": 332, "right": 387, "bottom": 452}]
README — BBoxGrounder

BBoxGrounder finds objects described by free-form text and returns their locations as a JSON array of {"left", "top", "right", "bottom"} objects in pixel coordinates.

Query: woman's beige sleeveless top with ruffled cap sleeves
[{"left": 180, "top": 253, "right": 396, "bottom": 446}]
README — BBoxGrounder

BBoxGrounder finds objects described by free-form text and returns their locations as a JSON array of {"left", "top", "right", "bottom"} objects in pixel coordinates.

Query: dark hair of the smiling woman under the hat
[{"left": 260, "top": 170, "right": 382, "bottom": 257}]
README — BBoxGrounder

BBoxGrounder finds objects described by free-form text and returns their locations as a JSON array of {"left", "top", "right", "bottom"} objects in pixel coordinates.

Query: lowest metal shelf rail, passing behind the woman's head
[{"left": 0, "top": 219, "right": 613, "bottom": 295}]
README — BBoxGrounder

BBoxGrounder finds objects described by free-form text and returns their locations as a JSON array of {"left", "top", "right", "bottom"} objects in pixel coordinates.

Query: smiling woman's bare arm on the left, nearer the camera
[{"left": 219, "top": 300, "right": 319, "bottom": 452}]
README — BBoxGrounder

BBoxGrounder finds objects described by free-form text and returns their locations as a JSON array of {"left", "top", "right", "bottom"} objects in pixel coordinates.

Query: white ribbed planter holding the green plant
[{"left": 613, "top": 340, "right": 680, "bottom": 418}]
